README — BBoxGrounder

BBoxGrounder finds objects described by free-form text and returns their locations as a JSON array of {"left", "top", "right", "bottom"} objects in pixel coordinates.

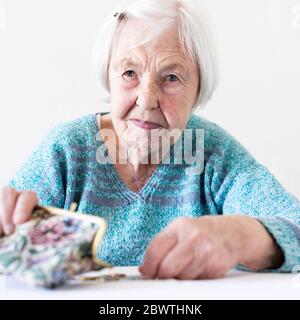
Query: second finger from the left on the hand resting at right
[{"left": 157, "top": 243, "right": 194, "bottom": 279}]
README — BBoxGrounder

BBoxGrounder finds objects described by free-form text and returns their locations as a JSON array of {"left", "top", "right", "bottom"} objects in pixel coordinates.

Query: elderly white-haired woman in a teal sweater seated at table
[{"left": 0, "top": 0, "right": 300, "bottom": 279}]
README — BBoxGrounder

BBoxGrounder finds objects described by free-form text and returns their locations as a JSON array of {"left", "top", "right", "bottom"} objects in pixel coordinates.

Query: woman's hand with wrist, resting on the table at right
[{"left": 139, "top": 215, "right": 284, "bottom": 280}]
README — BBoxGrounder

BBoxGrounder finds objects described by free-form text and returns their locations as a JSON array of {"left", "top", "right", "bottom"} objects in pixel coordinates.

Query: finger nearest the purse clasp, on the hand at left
[{"left": 13, "top": 190, "right": 38, "bottom": 224}]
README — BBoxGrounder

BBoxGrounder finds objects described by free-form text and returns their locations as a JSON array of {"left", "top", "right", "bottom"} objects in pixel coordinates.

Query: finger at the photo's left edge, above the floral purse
[{"left": 0, "top": 186, "right": 19, "bottom": 235}]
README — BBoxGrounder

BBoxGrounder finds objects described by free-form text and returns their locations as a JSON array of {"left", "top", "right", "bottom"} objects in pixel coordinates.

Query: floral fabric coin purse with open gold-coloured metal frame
[{"left": 0, "top": 203, "right": 112, "bottom": 288}]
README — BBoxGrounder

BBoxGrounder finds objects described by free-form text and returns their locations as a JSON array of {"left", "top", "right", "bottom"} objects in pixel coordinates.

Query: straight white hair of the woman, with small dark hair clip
[{"left": 93, "top": 0, "right": 219, "bottom": 110}]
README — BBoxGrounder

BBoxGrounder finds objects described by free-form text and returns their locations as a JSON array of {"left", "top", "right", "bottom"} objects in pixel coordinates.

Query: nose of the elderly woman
[{"left": 136, "top": 80, "right": 159, "bottom": 109}]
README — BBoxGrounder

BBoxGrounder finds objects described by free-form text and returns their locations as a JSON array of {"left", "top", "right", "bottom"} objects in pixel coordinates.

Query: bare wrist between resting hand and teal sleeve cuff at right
[{"left": 234, "top": 215, "right": 284, "bottom": 270}]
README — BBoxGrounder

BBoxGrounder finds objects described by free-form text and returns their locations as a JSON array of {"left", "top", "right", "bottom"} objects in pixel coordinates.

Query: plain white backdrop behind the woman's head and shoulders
[{"left": 0, "top": 0, "right": 300, "bottom": 199}]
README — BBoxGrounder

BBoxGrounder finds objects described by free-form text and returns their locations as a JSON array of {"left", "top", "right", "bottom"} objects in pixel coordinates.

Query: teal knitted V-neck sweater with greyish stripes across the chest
[{"left": 8, "top": 113, "right": 300, "bottom": 272}]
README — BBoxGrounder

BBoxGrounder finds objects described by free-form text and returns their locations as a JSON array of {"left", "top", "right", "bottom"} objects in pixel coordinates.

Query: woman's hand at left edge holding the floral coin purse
[{"left": 0, "top": 186, "right": 38, "bottom": 236}]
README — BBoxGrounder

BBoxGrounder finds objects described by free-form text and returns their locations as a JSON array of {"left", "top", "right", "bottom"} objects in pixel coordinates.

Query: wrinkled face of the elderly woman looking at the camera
[{"left": 109, "top": 19, "right": 199, "bottom": 162}]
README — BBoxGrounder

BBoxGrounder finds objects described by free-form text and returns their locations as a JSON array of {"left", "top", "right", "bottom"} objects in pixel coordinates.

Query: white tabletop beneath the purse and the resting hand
[{"left": 0, "top": 267, "right": 300, "bottom": 300}]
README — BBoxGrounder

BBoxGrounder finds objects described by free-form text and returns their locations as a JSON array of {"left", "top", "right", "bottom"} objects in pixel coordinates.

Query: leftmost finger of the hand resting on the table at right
[{"left": 140, "top": 231, "right": 177, "bottom": 278}]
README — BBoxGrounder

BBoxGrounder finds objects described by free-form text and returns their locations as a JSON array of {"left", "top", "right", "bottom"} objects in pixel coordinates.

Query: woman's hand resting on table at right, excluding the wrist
[{"left": 139, "top": 216, "right": 240, "bottom": 279}]
